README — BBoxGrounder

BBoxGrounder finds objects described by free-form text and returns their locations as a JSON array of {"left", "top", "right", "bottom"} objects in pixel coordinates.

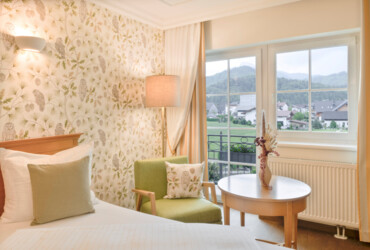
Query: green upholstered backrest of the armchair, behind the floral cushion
[{"left": 134, "top": 156, "right": 188, "bottom": 203}]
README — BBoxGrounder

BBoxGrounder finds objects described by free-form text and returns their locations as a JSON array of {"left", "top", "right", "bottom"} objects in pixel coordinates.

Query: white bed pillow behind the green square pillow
[{"left": 0, "top": 143, "right": 93, "bottom": 223}]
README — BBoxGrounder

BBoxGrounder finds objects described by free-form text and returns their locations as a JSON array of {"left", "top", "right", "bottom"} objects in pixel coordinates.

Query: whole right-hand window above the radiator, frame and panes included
[{"left": 269, "top": 36, "right": 357, "bottom": 143}]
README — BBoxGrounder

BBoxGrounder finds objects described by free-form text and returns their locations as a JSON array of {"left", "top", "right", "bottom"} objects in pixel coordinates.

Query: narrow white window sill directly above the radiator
[{"left": 278, "top": 141, "right": 357, "bottom": 152}]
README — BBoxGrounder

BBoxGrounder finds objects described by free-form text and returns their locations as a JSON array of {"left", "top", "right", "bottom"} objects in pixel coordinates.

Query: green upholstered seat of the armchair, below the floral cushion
[{"left": 141, "top": 198, "right": 222, "bottom": 224}]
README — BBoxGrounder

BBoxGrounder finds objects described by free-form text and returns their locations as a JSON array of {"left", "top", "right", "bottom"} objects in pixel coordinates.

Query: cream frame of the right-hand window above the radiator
[{"left": 267, "top": 34, "right": 358, "bottom": 145}]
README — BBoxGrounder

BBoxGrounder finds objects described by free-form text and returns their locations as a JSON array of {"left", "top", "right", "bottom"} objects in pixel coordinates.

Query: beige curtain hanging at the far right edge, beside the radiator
[{"left": 357, "top": 0, "right": 370, "bottom": 242}]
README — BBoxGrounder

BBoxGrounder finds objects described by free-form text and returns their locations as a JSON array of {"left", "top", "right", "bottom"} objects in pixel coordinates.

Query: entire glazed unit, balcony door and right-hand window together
[{"left": 206, "top": 34, "right": 358, "bottom": 182}]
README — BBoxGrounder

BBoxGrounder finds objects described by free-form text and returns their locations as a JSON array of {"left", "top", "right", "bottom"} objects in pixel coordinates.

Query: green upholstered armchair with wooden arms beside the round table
[{"left": 132, "top": 156, "right": 222, "bottom": 224}]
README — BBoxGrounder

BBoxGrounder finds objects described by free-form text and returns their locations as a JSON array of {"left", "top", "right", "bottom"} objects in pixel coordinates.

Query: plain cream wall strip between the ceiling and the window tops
[{"left": 205, "top": 0, "right": 361, "bottom": 50}]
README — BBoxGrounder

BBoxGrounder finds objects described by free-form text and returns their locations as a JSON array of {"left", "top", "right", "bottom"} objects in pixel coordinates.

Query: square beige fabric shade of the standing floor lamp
[{"left": 145, "top": 75, "right": 180, "bottom": 107}]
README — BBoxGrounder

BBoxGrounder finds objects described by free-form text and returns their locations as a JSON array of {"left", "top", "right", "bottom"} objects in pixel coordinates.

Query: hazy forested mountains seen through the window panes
[{"left": 206, "top": 66, "right": 348, "bottom": 107}]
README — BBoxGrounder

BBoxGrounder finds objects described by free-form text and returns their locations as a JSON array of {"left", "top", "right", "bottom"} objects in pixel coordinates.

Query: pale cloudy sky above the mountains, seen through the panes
[{"left": 206, "top": 46, "right": 348, "bottom": 76}]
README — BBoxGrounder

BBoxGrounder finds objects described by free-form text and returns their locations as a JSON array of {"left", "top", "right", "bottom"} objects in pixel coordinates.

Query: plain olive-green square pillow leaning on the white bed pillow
[{"left": 28, "top": 156, "right": 95, "bottom": 225}]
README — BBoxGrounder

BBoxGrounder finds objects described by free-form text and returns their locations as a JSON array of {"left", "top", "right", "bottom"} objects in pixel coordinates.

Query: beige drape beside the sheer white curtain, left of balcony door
[{"left": 179, "top": 23, "right": 208, "bottom": 180}]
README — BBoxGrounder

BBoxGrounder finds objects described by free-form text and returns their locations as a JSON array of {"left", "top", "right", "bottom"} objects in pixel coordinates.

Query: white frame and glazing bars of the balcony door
[{"left": 206, "top": 47, "right": 263, "bottom": 176}]
